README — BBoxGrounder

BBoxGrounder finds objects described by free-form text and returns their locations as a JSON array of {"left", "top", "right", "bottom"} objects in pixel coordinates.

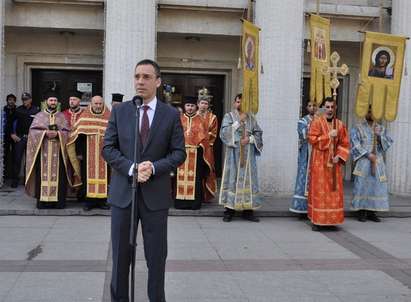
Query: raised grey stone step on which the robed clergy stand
[{"left": 0, "top": 182, "right": 411, "bottom": 217}]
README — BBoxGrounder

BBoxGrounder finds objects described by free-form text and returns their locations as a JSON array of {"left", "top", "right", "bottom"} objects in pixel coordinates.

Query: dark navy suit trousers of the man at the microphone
[{"left": 111, "top": 192, "right": 168, "bottom": 302}]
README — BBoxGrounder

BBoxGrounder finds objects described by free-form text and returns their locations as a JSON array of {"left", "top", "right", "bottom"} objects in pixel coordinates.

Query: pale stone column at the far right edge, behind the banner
[{"left": 387, "top": 0, "right": 411, "bottom": 196}]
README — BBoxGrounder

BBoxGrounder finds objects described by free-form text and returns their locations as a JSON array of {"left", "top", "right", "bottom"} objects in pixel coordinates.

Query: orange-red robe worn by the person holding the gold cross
[{"left": 308, "top": 116, "right": 350, "bottom": 225}]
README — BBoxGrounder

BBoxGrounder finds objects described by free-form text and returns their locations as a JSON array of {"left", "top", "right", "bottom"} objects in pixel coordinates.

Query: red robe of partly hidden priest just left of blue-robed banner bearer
[{"left": 199, "top": 111, "right": 218, "bottom": 201}]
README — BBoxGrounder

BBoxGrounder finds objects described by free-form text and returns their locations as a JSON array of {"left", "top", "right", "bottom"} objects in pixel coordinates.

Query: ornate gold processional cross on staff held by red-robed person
[{"left": 322, "top": 51, "right": 349, "bottom": 191}]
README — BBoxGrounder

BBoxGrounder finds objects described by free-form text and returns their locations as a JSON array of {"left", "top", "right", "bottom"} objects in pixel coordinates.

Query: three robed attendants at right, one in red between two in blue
[{"left": 290, "top": 98, "right": 393, "bottom": 231}]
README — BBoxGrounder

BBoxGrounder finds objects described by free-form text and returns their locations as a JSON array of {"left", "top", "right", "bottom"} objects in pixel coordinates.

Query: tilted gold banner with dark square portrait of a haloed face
[{"left": 355, "top": 32, "right": 406, "bottom": 122}]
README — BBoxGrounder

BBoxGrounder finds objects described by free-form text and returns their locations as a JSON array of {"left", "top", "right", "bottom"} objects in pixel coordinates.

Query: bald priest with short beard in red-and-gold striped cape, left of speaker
[{"left": 67, "top": 95, "right": 110, "bottom": 211}]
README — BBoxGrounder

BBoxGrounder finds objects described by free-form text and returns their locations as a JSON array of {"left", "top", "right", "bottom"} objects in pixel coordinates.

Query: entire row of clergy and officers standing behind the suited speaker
[{"left": 3, "top": 88, "right": 393, "bottom": 231}]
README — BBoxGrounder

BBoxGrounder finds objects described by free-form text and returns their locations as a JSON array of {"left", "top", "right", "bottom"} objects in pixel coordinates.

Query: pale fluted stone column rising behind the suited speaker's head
[{"left": 104, "top": 0, "right": 157, "bottom": 104}]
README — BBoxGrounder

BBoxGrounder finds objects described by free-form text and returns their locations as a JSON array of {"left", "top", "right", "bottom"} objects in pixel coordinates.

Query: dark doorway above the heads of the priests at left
[{"left": 31, "top": 69, "right": 103, "bottom": 110}]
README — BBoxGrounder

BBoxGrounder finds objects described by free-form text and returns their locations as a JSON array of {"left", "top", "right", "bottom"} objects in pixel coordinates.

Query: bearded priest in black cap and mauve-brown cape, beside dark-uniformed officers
[{"left": 26, "top": 92, "right": 80, "bottom": 209}]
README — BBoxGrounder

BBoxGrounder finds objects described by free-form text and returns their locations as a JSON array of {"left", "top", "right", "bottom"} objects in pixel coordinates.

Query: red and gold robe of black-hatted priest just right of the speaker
[{"left": 176, "top": 114, "right": 217, "bottom": 201}]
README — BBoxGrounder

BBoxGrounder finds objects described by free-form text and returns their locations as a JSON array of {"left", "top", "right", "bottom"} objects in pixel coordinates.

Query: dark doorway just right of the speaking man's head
[{"left": 160, "top": 73, "right": 225, "bottom": 177}]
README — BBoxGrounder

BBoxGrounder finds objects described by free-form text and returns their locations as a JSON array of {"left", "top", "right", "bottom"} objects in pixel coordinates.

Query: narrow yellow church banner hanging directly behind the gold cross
[{"left": 310, "top": 15, "right": 331, "bottom": 105}]
